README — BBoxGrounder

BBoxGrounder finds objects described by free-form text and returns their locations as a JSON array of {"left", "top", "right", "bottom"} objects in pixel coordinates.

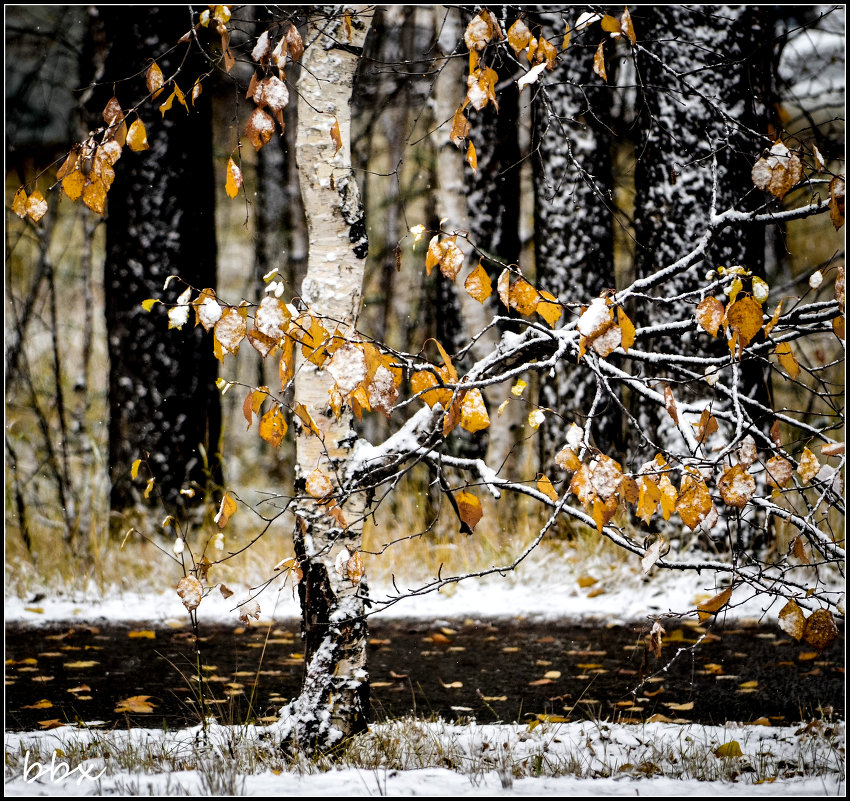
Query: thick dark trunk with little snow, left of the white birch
[{"left": 88, "top": 6, "right": 221, "bottom": 513}]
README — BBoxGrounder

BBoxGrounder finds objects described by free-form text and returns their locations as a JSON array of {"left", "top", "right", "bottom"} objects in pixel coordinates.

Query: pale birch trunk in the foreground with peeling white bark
[{"left": 285, "top": 6, "right": 373, "bottom": 751}]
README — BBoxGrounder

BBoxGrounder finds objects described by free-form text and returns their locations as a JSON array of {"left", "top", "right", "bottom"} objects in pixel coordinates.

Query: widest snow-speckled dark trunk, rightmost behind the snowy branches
[{"left": 632, "top": 5, "right": 772, "bottom": 459}]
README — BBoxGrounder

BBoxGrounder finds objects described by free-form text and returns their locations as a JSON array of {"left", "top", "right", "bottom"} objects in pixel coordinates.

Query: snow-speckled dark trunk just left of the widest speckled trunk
[{"left": 526, "top": 15, "right": 622, "bottom": 465}]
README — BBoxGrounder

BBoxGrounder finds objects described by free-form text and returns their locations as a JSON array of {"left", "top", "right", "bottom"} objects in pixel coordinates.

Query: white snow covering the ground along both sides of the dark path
[{"left": 5, "top": 564, "right": 844, "bottom": 796}]
